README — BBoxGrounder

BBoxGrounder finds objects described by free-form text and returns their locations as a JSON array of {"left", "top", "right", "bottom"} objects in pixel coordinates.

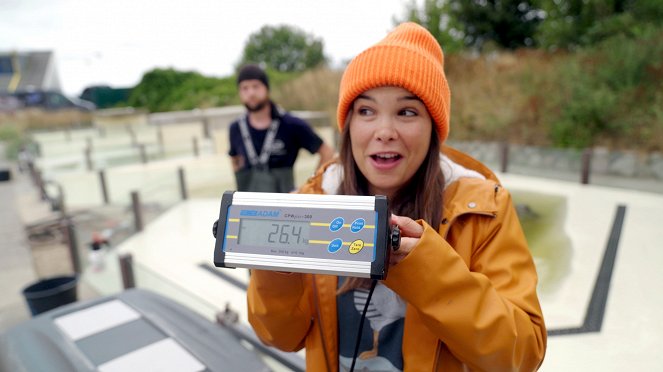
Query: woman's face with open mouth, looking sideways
[{"left": 349, "top": 87, "right": 433, "bottom": 197}]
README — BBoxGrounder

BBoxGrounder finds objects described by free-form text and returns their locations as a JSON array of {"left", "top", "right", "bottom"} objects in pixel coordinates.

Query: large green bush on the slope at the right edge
[{"left": 547, "top": 27, "right": 663, "bottom": 148}]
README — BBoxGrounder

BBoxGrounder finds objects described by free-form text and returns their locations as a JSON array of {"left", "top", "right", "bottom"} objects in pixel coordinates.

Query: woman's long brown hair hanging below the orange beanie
[{"left": 337, "top": 107, "right": 444, "bottom": 294}]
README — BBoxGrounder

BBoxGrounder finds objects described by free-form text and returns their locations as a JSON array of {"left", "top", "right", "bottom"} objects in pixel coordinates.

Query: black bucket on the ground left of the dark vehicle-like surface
[{"left": 23, "top": 276, "right": 78, "bottom": 316}]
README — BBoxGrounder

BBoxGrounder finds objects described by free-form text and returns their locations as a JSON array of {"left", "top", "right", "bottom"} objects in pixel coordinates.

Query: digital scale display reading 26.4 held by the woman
[{"left": 213, "top": 191, "right": 400, "bottom": 279}]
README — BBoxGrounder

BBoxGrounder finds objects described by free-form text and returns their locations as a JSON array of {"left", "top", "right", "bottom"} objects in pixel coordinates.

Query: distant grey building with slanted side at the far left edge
[{"left": 0, "top": 51, "right": 61, "bottom": 94}]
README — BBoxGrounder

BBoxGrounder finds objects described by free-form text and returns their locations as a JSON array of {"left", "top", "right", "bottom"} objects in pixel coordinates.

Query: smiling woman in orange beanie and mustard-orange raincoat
[{"left": 248, "top": 23, "right": 546, "bottom": 371}]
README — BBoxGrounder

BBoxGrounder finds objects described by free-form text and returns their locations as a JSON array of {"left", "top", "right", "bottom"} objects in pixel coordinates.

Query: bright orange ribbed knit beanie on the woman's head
[{"left": 337, "top": 22, "right": 451, "bottom": 142}]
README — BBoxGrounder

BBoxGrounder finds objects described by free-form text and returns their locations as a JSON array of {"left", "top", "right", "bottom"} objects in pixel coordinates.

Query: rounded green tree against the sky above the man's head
[{"left": 239, "top": 25, "right": 327, "bottom": 72}]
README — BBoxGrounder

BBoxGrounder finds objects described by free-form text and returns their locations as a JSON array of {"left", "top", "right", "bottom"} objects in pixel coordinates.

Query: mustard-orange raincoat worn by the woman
[{"left": 248, "top": 147, "right": 546, "bottom": 372}]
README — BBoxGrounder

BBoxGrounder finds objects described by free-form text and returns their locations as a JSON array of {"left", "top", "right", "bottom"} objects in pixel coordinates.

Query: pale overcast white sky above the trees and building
[{"left": 0, "top": 0, "right": 416, "bottom": 96}]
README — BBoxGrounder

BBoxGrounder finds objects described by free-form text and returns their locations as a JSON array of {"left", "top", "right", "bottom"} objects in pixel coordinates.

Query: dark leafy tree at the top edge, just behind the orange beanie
[{"left": 406, "top": 0, "right": 544, "bottom": 51}]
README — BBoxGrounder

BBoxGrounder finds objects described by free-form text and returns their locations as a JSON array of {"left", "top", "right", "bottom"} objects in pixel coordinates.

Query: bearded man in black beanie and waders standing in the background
[{"left": 228, "top": 65, "right": 334, "bottom": 192}]
